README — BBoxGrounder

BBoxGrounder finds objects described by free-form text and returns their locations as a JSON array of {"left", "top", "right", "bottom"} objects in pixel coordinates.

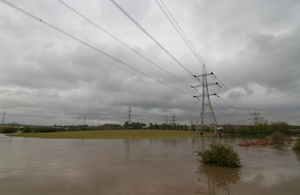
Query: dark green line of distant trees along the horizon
[{"left": 0, "top": 121, "right": 294, "bottom": 135}]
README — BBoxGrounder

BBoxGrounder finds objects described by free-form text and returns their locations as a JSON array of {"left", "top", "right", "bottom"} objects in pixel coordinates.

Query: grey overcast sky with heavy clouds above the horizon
[{"left": 0, "top": 0, "right": 300, "bottom": 125}]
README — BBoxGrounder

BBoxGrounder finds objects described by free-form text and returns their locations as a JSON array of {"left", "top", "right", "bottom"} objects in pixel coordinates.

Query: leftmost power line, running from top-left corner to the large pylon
[{"left": 1, "top": 0, "right": 191, "bottom": 96}]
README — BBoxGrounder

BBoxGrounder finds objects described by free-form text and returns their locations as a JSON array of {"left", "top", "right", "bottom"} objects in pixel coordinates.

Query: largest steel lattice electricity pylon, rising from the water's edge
[{"left": 191, "top": 64, "right": 221, "bottom": 136}]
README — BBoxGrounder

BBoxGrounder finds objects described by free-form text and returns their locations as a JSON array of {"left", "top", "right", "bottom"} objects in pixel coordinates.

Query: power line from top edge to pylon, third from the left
[{"left": 110, "top": 0, "right": 195, "bottom": 76}]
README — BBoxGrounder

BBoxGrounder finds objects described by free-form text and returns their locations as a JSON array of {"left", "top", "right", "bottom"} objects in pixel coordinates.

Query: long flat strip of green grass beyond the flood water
[{"left": 11, "top": 130, "right": 214, "bottom": 139}]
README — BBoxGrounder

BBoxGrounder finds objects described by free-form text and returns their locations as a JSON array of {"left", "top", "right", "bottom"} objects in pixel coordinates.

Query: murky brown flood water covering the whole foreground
[{"left": 0, "top": 135, "right": 300, "bottom": 195}]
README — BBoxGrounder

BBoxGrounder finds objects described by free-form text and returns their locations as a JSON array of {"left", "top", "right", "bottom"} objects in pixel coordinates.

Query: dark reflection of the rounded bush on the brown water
[{"left": 196, "top": 164, "right": 241, "bottom": 195}]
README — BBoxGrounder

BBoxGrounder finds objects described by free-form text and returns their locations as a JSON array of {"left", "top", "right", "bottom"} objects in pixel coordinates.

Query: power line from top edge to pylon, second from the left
[{"left": 58, "top": 0, "right": 190, "bottom": 86}]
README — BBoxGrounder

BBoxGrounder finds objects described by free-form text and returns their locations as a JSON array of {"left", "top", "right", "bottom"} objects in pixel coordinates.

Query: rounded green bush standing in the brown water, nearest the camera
[{"left": 198, "top": 144, "right": 241, "bottom": 167}]
